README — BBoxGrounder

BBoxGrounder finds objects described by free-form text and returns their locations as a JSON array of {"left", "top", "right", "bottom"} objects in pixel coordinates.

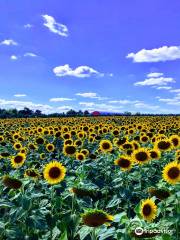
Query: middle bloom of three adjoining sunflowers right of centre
[{"left": 132, "top": 148, "right": 150, "bottom": 164}]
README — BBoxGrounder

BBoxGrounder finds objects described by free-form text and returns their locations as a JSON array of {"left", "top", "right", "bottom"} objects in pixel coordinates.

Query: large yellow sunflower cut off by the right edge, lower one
[{"left": 162, "top": 161, "right": 180, "bottom": 184}]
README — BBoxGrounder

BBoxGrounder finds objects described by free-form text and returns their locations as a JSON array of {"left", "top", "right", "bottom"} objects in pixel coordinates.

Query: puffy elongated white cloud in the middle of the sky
[{"left": 53, "top": 64, "right": 104, "bottom": 78}]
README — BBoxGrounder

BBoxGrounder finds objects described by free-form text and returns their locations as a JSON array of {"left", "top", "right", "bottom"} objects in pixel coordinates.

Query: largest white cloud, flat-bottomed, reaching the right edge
[{"left": 126, "top": 46, "right": 180, "bottom": 62}]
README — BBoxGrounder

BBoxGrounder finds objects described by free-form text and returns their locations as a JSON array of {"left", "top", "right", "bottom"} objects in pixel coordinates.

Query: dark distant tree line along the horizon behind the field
[{"left": 0, "top": 107, "right": 180, "bottom": 118}]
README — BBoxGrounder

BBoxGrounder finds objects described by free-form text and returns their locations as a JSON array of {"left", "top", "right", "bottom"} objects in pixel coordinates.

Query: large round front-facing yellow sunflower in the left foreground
[{"left": 43, "top": 161, "right": 66, "bottom": 184}]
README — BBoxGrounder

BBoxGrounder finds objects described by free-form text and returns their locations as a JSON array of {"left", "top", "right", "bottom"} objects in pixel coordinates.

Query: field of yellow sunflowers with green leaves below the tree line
[{"left": 0, "top": 116, "right": 180, "bottom": 240}]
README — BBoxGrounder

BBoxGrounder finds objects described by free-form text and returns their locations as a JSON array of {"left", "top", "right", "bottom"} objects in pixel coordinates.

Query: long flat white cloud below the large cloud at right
[{"left": 134, "top": 77, "right": 175, "bottom": 86}]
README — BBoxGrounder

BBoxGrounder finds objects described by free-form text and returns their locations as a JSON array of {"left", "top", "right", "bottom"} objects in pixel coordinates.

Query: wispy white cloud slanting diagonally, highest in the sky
[{"left": 42, "top": 14, "right": 68, "bottom": 37}]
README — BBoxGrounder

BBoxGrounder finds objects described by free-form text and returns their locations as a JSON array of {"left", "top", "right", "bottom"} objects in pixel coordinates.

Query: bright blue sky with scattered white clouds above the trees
[{"left": 0, "top": 0, "right": 180, "bottom": 113}]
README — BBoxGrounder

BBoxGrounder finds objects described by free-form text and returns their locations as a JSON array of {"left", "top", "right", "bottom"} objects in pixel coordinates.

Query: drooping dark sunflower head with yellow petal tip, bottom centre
[{"left": 82, "top": 209, "right": 113, "bottom": 227}]
